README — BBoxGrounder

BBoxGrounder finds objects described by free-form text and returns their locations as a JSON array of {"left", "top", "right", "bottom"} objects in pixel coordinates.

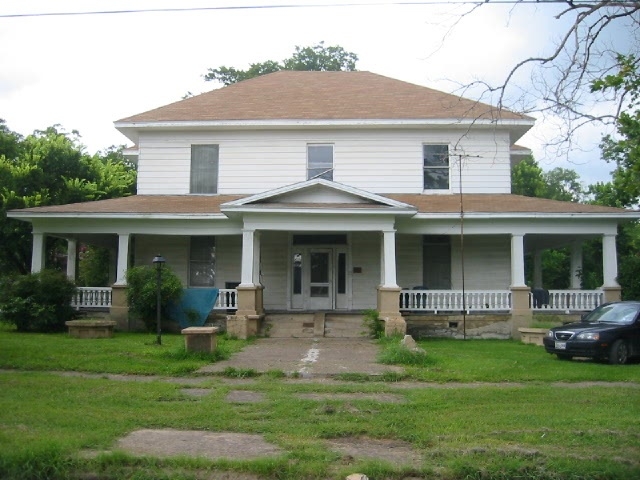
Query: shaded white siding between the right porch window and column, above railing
[{"left": 451, "top": 235, "right": 511, "bottom": 290}]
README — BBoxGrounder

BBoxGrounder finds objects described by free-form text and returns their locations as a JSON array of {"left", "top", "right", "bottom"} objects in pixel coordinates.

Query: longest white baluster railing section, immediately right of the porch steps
[{"left": 400, "top": 290, "right": 511, "bottom": 313}]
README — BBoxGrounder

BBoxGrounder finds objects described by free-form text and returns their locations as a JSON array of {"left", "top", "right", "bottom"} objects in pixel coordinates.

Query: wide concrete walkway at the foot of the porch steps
[{"left": 197, "top": 337, "right": 402, "bottom": 377}]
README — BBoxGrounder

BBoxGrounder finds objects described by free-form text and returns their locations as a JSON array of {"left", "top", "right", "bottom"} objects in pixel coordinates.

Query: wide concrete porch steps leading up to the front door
[{"left": 260, "top": 312, "right": 365, "bottom": 338}]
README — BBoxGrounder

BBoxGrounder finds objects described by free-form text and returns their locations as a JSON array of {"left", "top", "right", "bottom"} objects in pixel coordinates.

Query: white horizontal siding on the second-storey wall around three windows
[{"left": 138, "top": 129, "right": 511, "bottom": 195}]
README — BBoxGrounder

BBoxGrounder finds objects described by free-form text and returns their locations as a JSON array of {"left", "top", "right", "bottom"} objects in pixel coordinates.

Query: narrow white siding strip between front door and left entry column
[{"left": 260, "top": 232, "right": 289, "bottom": 310}]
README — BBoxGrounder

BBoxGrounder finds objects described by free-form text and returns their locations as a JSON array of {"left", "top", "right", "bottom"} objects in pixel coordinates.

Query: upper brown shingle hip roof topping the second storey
[{"left": 116, "top": 71, "right": 533, "bottom": 123}]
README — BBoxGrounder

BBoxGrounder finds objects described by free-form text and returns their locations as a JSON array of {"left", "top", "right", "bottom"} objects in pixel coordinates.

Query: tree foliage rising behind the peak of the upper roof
[{"left": 204, "top": 42, "right": 358, "bottom": 86}]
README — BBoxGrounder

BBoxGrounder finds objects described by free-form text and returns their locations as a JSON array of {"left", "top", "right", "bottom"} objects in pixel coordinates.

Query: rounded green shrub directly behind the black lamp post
[{"left": 127, "top": 265, "right": 182, "bottom": 331}]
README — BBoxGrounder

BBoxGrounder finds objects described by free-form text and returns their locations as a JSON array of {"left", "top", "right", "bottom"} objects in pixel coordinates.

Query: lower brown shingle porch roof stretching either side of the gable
[{"left": 8, "top": 194, "right": 638, "bottom": 216}]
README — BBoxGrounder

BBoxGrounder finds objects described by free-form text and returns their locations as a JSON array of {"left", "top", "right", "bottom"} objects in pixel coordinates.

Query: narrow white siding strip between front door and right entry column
[{"left": 351, "top": 232, "right": 381, "bottom": 310}]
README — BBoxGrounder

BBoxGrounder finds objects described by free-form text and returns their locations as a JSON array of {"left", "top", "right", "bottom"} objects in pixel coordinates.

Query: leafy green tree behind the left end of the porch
[{"left": 0, "top": 120, "right": 136, "bottom": 274}]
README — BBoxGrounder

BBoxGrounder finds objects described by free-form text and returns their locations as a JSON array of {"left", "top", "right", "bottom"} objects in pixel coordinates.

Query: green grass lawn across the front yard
[{"left": 0, "top": 327, "right": 640, "bottom": 480}]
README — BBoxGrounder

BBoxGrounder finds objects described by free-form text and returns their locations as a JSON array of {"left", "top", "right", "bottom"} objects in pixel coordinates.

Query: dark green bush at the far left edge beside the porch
[{"left": 0, "top": 270, "right": 76, "bottom": 332}]
